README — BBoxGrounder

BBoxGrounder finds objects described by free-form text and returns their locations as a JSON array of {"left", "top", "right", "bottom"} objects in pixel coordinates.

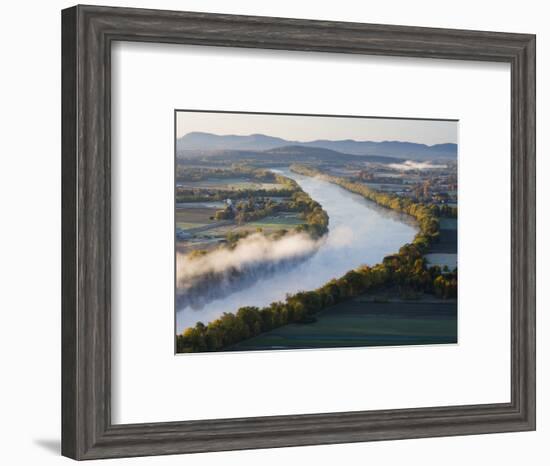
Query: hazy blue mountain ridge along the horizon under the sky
[{"left": 176, "top": 132, "right": 457, "bottom": 160}]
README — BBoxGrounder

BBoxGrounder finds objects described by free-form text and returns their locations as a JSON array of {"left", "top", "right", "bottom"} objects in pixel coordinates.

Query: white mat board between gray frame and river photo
[{"left": 111, "top": 42, "right": 510, "bottom": 423}]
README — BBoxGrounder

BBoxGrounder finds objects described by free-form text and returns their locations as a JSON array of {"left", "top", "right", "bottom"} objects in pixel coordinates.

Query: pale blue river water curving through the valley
[{"left": 176, "top": 170, "right": 417, "bottom": 333}]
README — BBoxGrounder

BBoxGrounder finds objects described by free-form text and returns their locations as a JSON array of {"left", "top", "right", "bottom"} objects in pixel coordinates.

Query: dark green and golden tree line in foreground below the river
[{"left": 176, "top": 244, "right": 457, "bottom": 353}]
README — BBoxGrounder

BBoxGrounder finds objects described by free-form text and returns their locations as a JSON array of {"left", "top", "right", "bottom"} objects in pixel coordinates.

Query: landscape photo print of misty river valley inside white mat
[{"left": 174, "top": 110, "right": 458, "bottom": 353}]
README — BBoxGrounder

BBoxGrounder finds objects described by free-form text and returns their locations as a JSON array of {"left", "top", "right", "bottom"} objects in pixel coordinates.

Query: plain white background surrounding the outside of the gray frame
[{"left": 0, "top": 0, "right": 550, "bottom": 466}]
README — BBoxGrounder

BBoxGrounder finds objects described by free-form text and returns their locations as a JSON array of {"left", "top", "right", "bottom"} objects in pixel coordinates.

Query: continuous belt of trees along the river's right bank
[{"left": 176, "top": 165, "right": 458, "bottom": 353}]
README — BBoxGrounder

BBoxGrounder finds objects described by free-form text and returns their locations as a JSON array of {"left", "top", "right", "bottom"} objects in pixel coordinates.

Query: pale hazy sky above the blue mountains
[{"left": 177, "top": 111, "right": 458, "bottom": 145}]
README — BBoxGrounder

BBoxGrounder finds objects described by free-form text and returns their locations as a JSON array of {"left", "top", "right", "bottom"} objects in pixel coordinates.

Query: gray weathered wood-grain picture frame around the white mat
[{"left": 62, "top": 6, "right": 535, "bottom": 459}]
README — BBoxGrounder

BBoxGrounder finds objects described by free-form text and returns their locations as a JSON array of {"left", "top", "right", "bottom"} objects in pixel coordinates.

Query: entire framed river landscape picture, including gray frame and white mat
[{"left": 62, "top": 6, "right": 535, "bottom": 459}]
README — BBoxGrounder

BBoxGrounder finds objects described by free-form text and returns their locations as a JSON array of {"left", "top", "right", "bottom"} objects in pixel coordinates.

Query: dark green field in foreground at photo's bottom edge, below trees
[{"left": 227, "top": 298, "right": 457, "bottom": 351}]
